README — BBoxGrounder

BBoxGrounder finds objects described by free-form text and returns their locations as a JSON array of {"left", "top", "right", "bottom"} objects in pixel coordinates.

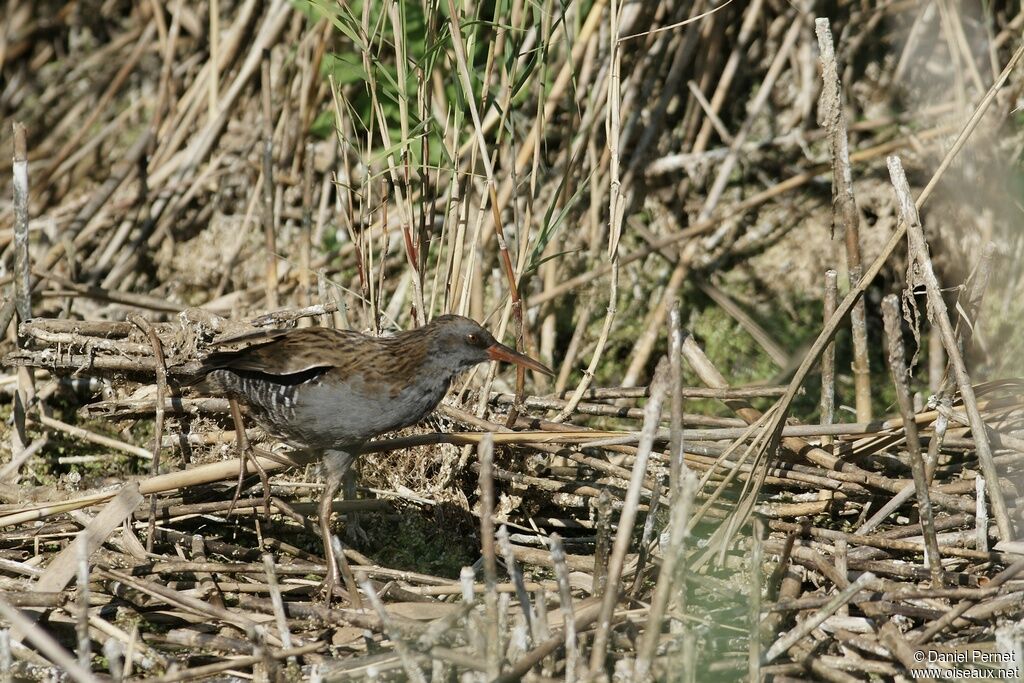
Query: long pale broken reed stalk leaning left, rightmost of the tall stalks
[{"left": 887, "top": 157, "right": 1016, "bottom": 541}]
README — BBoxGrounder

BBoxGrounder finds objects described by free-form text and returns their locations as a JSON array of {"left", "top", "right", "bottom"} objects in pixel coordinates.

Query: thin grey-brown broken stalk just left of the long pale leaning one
[{"left": 882, "top": 294, "right": 942, "bottom": 588}]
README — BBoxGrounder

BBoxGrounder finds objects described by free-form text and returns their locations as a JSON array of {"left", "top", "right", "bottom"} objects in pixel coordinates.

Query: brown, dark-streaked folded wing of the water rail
[{"left": 203, "top": 328, "right": 366, "bottom": 377}]
